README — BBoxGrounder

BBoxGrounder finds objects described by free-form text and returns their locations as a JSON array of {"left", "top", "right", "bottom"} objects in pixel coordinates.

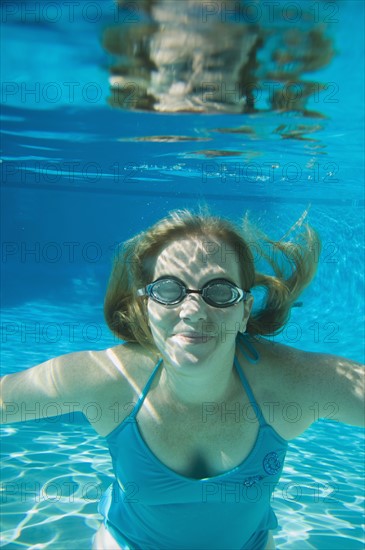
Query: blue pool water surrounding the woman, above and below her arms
[{"left": 1, "top": 0, "right": 364, "bottom": 550}]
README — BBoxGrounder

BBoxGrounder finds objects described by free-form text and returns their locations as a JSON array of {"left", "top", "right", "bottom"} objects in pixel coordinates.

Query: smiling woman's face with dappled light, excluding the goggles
[{"left": 148, "top": 237, "right": 252, "bottom": 368}]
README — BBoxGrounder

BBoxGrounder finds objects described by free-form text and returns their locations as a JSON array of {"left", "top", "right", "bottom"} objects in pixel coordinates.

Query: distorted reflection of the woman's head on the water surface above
[{"left": 102, "top": 0, "right": 336, "bottom": 117}]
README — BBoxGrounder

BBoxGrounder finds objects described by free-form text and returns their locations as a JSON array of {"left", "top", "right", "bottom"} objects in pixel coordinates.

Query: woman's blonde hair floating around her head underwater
[{"left": 104, "top": 210, "right": 320, "bottom": 348}]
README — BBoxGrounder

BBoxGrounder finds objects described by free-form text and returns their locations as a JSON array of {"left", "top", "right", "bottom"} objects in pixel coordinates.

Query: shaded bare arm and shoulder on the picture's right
[{"left": 243, "top": 339, "right": 365, "bottom": 439}]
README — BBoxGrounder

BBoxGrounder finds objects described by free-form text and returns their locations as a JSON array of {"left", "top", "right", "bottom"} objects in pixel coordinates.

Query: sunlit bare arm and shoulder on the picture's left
[{"left": 1, "top": 344, "right": 155, "bottom": 435}]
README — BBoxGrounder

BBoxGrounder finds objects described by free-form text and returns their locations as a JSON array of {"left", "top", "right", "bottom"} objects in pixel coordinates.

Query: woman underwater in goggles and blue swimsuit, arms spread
[{"left": 2, "top": 210, "right": 364, "bottom": 550}]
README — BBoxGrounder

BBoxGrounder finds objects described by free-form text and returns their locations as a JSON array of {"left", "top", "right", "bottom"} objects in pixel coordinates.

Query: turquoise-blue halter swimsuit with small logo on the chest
[{"left": 99, "top": 338, "right": 287, "bottom": 550}]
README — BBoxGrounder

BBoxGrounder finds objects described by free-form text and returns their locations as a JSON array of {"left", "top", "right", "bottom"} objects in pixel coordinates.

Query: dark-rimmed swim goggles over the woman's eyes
[{"left": 137, "top": 276, "right": 249, "bottom": 308}]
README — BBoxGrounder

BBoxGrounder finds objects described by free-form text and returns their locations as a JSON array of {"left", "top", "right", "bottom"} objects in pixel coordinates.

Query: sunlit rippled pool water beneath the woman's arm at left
[{"left": 2, "top": 423, "right": 111, "bottom": 550}]
